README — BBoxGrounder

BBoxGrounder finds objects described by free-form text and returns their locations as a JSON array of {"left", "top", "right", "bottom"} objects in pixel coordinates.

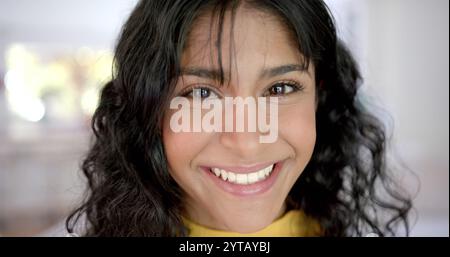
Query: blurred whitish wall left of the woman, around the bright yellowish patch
[{"left": 0, "top": 0, "right": 136, "bottom": 236}]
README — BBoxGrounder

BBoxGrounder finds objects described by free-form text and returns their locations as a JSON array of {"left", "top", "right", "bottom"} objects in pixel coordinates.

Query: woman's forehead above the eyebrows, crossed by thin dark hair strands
[{"left": 181, "top": 6, "right": 304, "bottom": 69}]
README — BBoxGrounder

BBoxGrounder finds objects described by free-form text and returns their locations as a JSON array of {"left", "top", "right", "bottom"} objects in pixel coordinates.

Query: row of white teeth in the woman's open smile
[{"left": 211, "top": 164, "right": 274, "bottom": 185}]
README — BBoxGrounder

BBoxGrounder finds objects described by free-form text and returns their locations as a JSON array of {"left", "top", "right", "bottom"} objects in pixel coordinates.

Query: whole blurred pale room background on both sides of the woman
[{"left": 0, "top": 0, "right": 449, "bottom": 236}]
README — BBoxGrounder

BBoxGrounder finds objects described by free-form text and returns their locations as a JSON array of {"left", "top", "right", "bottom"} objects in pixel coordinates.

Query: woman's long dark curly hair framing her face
[{"left": 66, "top": 0, "right": 411, "bottom": 236}]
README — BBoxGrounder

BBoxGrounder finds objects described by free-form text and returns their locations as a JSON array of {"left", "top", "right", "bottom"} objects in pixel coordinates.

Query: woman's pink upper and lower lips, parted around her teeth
[{"left": 200, "top": 161, "right": 283, "bottom": 196}]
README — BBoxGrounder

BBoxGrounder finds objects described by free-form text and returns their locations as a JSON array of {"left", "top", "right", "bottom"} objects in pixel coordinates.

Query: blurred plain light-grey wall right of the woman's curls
[{"left": 365, "top": 0, "right": 449, "bottom": 236}]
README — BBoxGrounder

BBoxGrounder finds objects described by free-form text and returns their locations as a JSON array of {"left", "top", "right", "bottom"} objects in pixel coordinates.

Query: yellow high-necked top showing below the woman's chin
[{"left": 183, "top": 210, "right": 321, "bottom": 237}]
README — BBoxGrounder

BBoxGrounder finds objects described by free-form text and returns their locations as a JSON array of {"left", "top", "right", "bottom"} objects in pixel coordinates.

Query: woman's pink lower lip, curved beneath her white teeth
[{"left": 202, "top": 162, "right": 283, "bottom": 196}]
